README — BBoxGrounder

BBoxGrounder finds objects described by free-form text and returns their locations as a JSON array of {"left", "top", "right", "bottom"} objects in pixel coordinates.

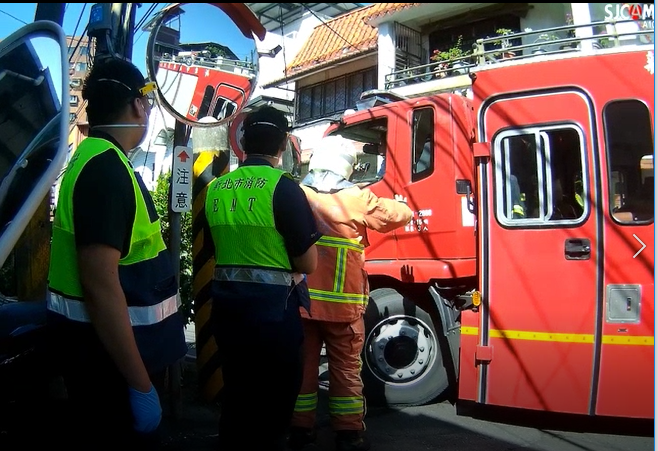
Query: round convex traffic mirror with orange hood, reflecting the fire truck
[{"left": 145, "top": 3, "right": 265, "bottom": 127}]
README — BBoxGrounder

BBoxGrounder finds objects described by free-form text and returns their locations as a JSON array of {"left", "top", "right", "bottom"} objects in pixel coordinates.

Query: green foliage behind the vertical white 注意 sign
[{"left": 151, "top": 173, "right": 194, "bottom": 324}]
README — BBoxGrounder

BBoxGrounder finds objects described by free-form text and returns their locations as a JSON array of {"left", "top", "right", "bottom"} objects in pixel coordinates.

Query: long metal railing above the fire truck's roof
[{"left": 384, "top": 20, "right": 654, "bottom": 89}]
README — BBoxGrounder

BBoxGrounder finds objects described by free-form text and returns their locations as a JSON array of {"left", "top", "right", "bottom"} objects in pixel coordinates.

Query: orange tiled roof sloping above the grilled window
[{"left": 286, "top": 3, "right": 418, "bottom": 77}]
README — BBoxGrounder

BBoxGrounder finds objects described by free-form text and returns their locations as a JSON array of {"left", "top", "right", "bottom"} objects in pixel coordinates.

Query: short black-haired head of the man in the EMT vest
[{"left": 242, "top": 105, "right": 291, "bottom": 155}]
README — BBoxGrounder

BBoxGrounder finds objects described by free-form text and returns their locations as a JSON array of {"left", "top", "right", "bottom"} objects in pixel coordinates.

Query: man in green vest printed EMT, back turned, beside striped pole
[{"left": 205, "top": 106, "right": 321, "bottom": 451}]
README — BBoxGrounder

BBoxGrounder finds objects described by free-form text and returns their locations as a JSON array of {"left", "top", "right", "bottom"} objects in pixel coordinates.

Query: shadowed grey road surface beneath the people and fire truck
[{"left": 155, "top": 364, "right": 654, "bottom": 451}]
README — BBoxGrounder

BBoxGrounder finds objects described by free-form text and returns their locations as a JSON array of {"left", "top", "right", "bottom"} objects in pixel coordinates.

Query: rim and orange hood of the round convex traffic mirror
[{"left": 146, "top": 2, "right": 267, "bottom": 128}]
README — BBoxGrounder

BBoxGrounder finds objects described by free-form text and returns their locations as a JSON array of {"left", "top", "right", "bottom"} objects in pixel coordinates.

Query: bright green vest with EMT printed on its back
[{"left": 205, "top": 165, "right": 292, "bottom": 272}]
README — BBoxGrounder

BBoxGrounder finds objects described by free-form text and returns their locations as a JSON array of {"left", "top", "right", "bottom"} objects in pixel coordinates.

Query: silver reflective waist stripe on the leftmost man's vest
[{"left": 47, "top": 293, "right": 180, "bottom": 326}]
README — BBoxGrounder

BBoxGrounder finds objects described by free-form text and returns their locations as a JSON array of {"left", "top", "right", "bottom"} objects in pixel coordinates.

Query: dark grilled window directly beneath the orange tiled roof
[{"left": 296, "top": 67, "right": 377, "bottom": 122}]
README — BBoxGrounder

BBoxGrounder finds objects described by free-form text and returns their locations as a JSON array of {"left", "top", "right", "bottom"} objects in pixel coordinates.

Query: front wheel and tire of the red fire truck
[{"left": 361, "top": 288, "right": 449, "bottom": 407}]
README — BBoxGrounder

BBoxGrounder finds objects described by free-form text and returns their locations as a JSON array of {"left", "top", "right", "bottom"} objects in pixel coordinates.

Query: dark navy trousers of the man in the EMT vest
[{"left": 211, "top": 282, "right": 304, "bottom": 451}]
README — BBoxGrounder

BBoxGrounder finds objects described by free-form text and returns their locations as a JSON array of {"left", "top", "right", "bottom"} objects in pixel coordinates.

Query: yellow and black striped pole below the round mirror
[{"left": 192, "top": 118, "right": 230, "bottom": 401}]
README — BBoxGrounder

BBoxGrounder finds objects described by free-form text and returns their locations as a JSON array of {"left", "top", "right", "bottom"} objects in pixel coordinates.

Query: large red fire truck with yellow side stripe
[{"left": 326, "top": 38, "right": 654, "bottom": 418}]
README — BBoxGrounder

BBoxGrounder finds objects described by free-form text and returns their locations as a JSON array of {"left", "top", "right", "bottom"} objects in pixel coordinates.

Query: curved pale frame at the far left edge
[{"left": 0, "top": 20, "right": 70, "bottom": 267}]
